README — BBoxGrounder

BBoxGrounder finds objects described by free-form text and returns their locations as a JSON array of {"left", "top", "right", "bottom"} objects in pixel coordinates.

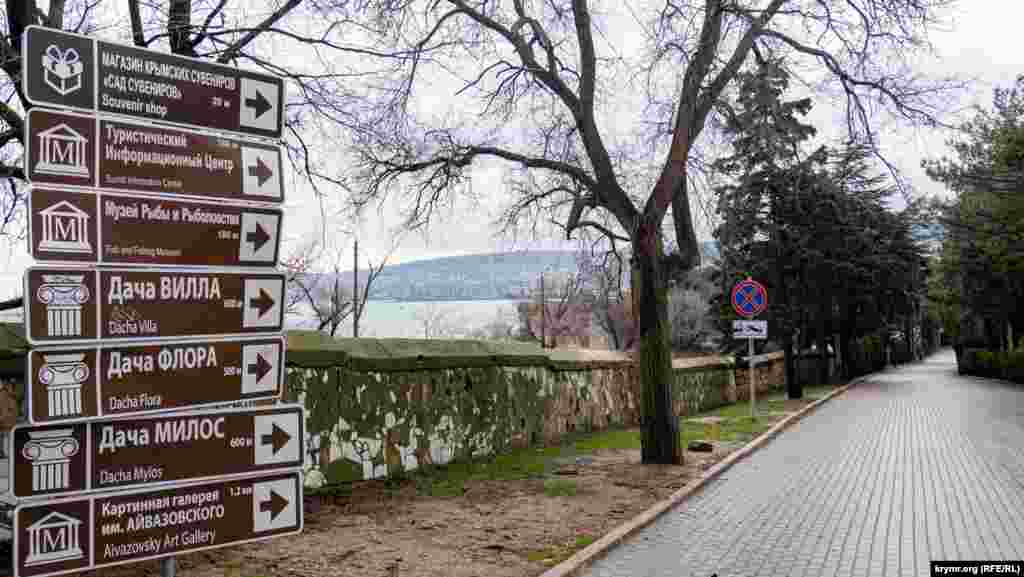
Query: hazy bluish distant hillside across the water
[{"left": 303, "top": 242, "right": 718, "bottom": 301}]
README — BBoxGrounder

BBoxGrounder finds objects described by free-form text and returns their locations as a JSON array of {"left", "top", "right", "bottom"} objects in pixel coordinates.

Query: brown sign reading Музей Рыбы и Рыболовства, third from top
[{"left": 29, "top": 188, "right": 282, "bottom": 267}]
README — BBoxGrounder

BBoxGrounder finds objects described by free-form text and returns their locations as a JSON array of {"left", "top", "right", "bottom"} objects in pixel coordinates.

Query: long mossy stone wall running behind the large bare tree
[{"left": 280, "top": 334, "right": 783, "bottom": 481}]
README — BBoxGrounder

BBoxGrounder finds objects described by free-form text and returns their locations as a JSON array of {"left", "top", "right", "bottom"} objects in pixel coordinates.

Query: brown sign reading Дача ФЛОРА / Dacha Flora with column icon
[{"left": 26, "top": 337, "right": 285, "bottom": 424}]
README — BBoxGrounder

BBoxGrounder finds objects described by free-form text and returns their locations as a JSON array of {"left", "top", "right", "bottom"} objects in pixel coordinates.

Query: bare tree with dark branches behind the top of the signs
[{"left": 0, "top": 0, "right": 399, "bottom": 311}]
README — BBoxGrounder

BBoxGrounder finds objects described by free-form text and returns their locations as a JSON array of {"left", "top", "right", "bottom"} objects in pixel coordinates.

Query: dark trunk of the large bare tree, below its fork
[{"left": 632, "top": 231, "right": 683, "bottom": 464}]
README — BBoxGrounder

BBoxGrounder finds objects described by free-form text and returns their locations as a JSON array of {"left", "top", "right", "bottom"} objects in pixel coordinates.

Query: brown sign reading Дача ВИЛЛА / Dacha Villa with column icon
[{"left": 25, "top": 267, "right": 285, "bottom": 345}]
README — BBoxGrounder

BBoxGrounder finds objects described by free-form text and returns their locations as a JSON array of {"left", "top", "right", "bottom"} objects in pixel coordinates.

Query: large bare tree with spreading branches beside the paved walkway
[{"left": 322, "top": 0, "right": 961, "bottom": 462}]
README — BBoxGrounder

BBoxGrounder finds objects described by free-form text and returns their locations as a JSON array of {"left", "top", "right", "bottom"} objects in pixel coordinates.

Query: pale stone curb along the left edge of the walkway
[{"left": 540, "top": 375, "right": 869, "bottom": 577}]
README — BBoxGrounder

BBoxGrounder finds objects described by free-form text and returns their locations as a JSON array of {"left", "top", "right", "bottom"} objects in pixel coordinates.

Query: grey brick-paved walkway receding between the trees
[{"left": 584, "top": 351, "right": 1024, "bottom": 577}]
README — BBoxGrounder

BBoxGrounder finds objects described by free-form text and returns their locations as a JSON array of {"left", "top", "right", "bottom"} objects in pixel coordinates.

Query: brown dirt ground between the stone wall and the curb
[{"left": 81, "top": 409, "right": 806, "bottom": 577}]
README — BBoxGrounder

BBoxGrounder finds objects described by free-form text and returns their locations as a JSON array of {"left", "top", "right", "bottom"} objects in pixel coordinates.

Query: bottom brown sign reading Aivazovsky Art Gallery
[{"left": 13, "top": 472, "right": 303, "bottom": 577}]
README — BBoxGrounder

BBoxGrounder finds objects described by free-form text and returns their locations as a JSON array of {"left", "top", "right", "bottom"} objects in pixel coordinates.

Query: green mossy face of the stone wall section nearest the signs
[{"left": 289, "top": 367, "right": 544, "bottom": 472}]
